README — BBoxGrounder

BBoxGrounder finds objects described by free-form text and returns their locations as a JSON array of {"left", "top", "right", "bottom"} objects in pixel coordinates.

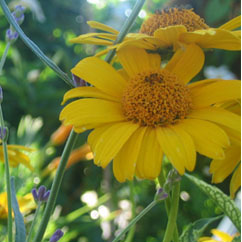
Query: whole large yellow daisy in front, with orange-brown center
[{"left": 60, "top": 45, "right": 240, "bottom": 182}]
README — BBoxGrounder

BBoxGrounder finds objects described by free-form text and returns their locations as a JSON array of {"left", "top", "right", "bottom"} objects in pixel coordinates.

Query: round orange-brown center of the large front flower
[{"left": 122, "top": 70, "right": 191, "bottom": 127}]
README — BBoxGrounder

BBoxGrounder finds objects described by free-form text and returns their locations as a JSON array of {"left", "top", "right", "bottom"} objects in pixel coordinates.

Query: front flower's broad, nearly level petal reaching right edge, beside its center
[{"left": 191, "top": 80, "right": 241, "bottom": 108}]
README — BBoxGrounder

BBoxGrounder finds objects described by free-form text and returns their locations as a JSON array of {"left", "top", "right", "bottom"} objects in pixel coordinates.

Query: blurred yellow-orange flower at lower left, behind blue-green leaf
[{"left": 0, "top": 192, "right": 36, "bottom": 219}]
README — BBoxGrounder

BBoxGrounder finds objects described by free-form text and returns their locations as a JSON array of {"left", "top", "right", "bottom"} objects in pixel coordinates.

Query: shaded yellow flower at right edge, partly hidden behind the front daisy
[{"left": 210, "top": 102, "right": 241, "bottom": 198}]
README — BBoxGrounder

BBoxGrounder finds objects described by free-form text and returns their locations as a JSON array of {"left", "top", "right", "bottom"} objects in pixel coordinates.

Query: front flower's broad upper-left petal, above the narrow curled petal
[{"left": 71, "top": 57, "right": 126, "bottom": 97}]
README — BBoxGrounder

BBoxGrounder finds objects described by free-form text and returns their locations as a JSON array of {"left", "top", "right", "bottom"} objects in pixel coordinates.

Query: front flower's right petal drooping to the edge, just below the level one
[{"left": 188, "top": 107, "right": 241, "bottom": 131}]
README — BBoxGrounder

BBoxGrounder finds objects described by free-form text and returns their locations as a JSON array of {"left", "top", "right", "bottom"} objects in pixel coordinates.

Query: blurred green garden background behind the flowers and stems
[{"left": 0, "top": 0, "right": 241, "bottom": 242}]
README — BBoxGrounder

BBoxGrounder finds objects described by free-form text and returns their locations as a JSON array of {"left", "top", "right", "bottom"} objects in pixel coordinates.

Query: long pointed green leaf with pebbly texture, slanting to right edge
[{"left": 185, "top": 174, "right": 241, "bottom": 231}]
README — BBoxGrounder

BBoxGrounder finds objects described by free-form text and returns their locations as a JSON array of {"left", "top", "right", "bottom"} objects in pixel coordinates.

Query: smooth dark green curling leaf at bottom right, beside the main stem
[{"left": 179, "top": 216, "right": 222, "bottom": 242}]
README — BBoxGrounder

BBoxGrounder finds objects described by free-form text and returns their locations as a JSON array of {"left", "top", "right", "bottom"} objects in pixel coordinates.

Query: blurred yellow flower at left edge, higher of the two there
[{"left": 0, "top": 145, "right": 33, "bottom": 171}]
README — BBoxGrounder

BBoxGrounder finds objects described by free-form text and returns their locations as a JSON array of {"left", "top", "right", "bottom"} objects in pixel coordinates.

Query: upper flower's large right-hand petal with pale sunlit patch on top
[{"left": 180, "top": 29, "right": 241, "bottom": 50}]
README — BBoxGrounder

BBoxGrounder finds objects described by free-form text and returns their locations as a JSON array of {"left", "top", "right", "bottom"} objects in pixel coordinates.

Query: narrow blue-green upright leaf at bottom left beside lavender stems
[{"left": 11, "top": 177, "right": 26, "bottom": 242}]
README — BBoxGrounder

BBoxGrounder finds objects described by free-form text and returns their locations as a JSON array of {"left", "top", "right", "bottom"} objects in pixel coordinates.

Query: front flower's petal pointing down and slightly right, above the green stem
[{"left": 156, "top": 127, "right": 196, "bottom": 174}]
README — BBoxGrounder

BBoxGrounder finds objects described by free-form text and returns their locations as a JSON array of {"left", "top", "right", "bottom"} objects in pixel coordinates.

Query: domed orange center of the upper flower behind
[{"left": 140, "top": 8, "right": 209, "bottom": 36}]
